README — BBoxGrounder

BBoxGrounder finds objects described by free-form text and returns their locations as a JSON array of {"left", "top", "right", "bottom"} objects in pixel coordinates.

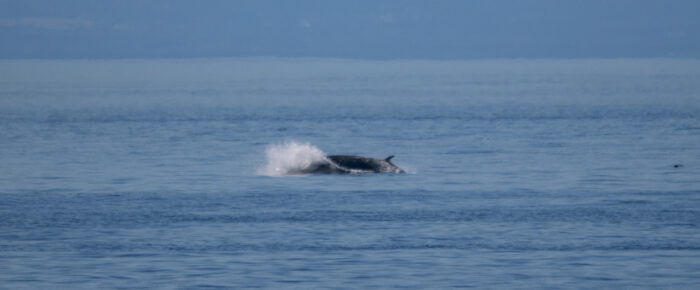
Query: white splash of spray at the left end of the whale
[{"left": 258, "top": 141, "right": 327, "bottom": 176}]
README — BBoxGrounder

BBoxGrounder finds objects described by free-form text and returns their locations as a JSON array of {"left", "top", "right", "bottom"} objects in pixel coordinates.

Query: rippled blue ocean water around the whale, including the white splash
[{"left": 0, "top": 58, "right": 700, "bottom": 289}]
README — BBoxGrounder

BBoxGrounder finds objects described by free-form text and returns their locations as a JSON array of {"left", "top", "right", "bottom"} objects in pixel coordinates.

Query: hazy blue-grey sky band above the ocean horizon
[{"left": 0, "top": 0, "right": 700, "bottom": 59}]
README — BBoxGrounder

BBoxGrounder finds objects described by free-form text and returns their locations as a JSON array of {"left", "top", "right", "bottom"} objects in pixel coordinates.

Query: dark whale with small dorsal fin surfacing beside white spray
[{"left": 304, "top": 155, "right": 406, "bottom": 174}]
